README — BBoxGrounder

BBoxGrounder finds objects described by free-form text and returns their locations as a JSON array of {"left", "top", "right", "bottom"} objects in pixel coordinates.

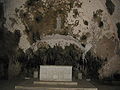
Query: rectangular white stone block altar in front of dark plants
[{"left": 39, "top": 65, "right": 72, "bottom": 81}]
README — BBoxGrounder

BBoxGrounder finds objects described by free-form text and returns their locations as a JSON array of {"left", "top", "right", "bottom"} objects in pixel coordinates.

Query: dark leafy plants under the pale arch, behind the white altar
[{"left": 19, "top": 44, "right": 104, "bottom": 80}]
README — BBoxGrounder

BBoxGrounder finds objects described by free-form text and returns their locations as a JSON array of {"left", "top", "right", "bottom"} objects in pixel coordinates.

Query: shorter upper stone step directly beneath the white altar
[{"left": 34, "top": 81, "right": 78, "bottom": 86}]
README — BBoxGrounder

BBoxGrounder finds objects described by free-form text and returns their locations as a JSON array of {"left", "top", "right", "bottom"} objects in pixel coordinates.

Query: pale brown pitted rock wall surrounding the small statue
[{"left": 1, "top": 0, "right": 120, "bottom": 76}]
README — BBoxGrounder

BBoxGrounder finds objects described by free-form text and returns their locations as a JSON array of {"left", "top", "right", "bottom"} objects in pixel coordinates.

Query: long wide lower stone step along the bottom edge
[{"left": 15, "top": 86, "right": 98, "bottom": 90}]
